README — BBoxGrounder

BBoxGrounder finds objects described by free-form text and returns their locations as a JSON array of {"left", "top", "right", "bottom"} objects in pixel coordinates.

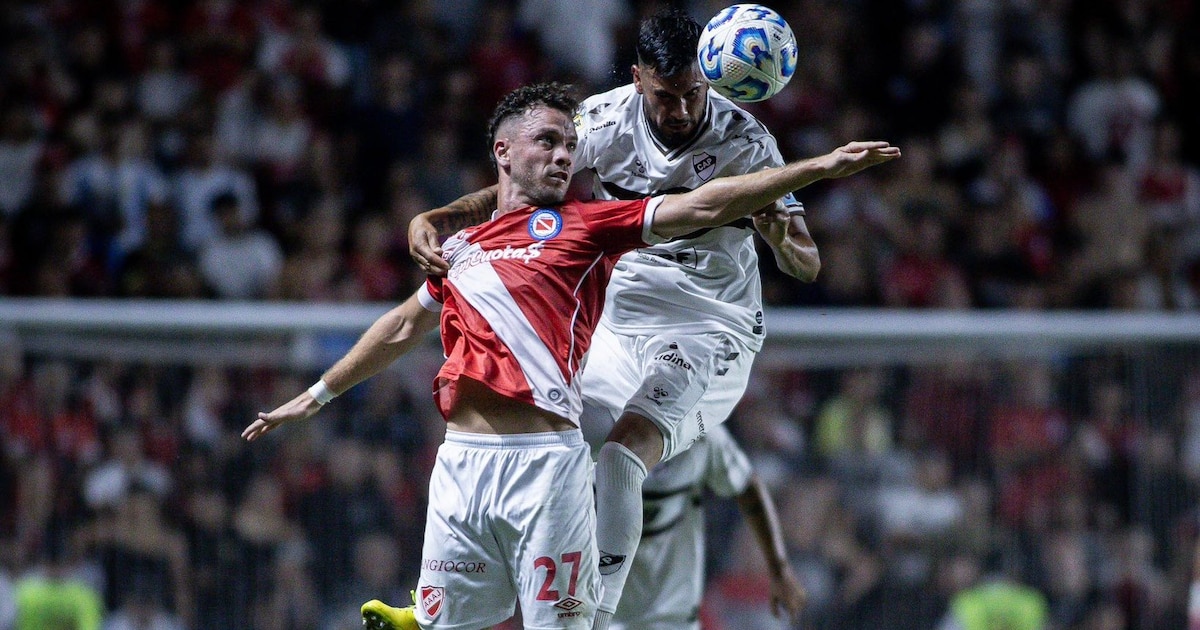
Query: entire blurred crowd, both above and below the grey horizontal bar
[{"left": 0, "top": 0, "right": 1200, "bottom": 630}]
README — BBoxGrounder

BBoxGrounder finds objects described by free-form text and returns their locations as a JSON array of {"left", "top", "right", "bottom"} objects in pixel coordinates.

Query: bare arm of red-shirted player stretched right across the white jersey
[{"left": 653, "top": 142, "right": 900, "bottom": 239}]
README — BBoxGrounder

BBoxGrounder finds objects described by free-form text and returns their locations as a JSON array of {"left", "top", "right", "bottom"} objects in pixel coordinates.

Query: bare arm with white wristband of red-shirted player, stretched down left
[{"left": 241, "top": 294, "right": 439, "bottom": 440}]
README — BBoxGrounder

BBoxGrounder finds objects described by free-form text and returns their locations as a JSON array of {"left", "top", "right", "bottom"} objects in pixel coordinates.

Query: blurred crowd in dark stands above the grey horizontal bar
[{"left": 0, "top": 0, "right": 1200, "bottom": 308}]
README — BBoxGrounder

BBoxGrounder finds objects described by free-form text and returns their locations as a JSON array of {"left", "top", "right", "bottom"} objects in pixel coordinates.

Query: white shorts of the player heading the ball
[{"left": 580, "top": 323, "right": 756, "bottom": 461}]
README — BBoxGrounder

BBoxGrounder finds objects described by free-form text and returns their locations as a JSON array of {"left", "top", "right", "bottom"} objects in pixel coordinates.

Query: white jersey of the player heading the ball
[{"left": 574, "top": 84, "right": 800, "bottom": 350}]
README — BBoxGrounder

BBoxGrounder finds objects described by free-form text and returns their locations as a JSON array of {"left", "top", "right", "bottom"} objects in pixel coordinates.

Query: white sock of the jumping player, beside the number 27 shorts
[{"left": 592, "top": 442, "right": 647, "bottom": 630}]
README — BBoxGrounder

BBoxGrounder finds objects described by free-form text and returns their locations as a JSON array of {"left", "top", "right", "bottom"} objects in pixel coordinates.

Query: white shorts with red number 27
[{"left": 416, "top": 431, "right": 600, "bottom": 630}]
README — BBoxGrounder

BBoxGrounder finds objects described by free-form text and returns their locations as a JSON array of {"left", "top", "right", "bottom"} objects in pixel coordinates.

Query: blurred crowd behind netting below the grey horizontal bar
[{"left": 0, "top": 331, "right": 1200, "bottom": 630}]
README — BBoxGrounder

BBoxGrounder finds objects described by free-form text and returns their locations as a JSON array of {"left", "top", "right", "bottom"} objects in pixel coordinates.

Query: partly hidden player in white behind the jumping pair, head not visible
[{"left": 610, "top": 425, "right": 803, "bottom": 630}]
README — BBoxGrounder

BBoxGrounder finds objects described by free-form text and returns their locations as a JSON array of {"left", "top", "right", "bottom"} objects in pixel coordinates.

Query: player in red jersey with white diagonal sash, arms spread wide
[{"left": 242, "top": 79, "right": 900, "bottom": 629}]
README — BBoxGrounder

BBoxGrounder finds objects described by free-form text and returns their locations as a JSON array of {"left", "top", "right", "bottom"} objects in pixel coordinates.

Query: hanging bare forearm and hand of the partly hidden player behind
[{"left": 738, "top": 475, "right": 808, "bottom": 622}]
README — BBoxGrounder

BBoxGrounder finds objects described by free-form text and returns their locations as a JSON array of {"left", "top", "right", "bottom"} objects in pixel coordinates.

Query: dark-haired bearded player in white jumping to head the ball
[{"left": 409, "top": 12, "right": 820, "bottom": 629}]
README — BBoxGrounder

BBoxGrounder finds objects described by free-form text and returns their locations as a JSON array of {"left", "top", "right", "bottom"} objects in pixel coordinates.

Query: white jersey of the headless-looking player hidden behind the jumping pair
[{"left": 612, "top": 426, "right": 752, "bottom": 630}]
